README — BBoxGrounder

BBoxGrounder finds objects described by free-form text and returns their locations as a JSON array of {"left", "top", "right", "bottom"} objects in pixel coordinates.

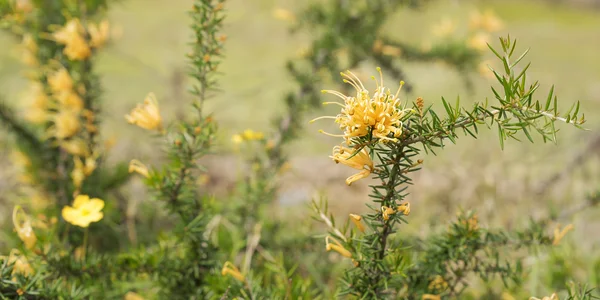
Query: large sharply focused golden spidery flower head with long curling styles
[{"left": 311, "top": 68, "right": 411, "bottom": 144}]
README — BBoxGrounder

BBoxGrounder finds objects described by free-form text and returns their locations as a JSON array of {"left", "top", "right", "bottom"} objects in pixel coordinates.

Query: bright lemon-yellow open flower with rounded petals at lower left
[{"left": 62, "top": 195, "right": 104, "bottom": 227}]
